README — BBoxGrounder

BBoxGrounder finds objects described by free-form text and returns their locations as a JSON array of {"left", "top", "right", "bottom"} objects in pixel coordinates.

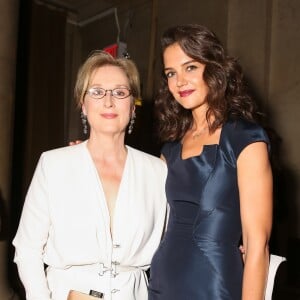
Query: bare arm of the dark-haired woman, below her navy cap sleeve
[{"left": 237, "top": 142, "right": 273, "bottom": 300}]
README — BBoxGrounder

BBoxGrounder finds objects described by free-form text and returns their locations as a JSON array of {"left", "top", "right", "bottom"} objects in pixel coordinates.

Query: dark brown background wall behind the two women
[{"left": 9, "top": 0, "right": 300, "bottom": 299}]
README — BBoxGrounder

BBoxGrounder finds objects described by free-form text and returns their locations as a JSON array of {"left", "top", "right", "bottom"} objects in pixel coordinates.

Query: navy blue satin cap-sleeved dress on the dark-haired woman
[{"left": 149, "top": 120, "right": 269, "bottom": 300}]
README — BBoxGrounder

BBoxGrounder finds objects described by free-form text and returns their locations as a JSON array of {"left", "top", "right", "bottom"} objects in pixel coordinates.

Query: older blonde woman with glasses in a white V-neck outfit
[{"left": 13, "top": 51, "right": 166, "bottom": 300}]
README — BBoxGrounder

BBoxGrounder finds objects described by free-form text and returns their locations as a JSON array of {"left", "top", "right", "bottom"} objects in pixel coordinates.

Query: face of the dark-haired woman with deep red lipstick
[{"left": 163, "top": 43, "right": 208, "bottom": 110}]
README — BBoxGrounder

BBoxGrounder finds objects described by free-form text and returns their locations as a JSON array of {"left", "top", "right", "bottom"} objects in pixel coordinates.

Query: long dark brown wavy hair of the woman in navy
[{"left": 155, "top": 24, "right": 259, "bottom": 142}]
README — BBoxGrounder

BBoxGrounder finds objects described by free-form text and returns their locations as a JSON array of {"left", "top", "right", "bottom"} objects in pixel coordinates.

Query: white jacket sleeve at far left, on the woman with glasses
[{"left": 13, "top": 156, "right": 51, "bottom": 300}]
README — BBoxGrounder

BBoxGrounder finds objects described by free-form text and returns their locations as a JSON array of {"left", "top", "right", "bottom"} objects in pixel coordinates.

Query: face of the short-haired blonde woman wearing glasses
[{"left": 82, "top": 65, "right": 134, "bottom": 134}]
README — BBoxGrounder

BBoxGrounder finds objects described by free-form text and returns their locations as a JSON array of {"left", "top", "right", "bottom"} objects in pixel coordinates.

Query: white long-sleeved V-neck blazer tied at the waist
[{"left": 13, "top": 142, "right": 167, "bottom": 300}]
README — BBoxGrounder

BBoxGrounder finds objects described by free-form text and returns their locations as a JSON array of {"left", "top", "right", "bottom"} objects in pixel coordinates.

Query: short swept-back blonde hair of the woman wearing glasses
[{"left": 74, "top": 50, "right": 141, "bottom": 108}]
